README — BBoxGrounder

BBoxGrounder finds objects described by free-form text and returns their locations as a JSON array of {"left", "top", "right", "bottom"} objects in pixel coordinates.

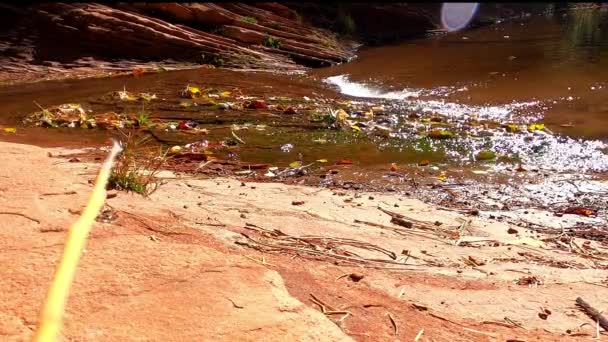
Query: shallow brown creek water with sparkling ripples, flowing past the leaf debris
[{"left": 0, "top": 10, "right": 608, "bottom": 219}]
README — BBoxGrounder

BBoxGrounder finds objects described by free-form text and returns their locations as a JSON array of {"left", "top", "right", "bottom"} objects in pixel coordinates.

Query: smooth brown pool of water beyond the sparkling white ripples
[{"left": 315, "top": 10, "right": 608, "bottom": 140}]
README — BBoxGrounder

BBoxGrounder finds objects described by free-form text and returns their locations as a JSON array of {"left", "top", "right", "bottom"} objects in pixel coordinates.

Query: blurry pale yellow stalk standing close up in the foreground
[{"left": 34, "top": 141, "right": 122, "bottom": 342}]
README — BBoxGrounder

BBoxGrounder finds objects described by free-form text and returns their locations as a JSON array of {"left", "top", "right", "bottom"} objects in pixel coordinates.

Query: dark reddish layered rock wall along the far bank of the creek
[{"left": 0, "top": 2, "right": 545, "bottom": 70}]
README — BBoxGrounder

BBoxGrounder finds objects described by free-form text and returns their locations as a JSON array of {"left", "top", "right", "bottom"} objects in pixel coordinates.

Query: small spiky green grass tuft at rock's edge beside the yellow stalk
[{"left": 108, "top": 131, "right": 167, "bottom": 196}]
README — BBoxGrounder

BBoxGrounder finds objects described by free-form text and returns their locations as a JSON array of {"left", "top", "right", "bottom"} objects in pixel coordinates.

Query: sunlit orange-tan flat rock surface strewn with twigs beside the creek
[{"left": 0, "top": 143, "right": 608, "bottom": 341}]
